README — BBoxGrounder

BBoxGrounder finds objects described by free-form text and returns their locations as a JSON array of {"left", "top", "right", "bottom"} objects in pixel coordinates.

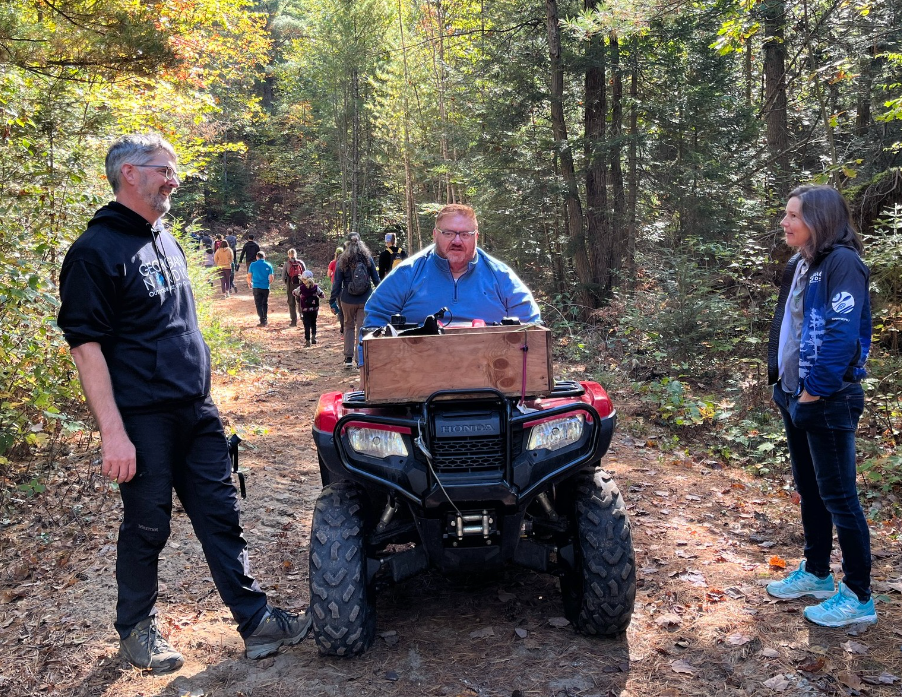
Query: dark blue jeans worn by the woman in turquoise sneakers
[{"left": 774, "top": 383, "right": 871, "bottom": 601}]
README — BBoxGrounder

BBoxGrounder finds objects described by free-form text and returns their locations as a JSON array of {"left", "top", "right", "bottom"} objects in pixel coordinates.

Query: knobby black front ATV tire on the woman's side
[{"left": 561, "top": 468, "right": 636, "bottom": 636}]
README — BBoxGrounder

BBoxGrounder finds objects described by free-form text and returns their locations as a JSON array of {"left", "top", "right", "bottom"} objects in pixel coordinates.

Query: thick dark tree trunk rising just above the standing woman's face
[{"left": 762, "top": 0, "right": 791, "bottom": 201}]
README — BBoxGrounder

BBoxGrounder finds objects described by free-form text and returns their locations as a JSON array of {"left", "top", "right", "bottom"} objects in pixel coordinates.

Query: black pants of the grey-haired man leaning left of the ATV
[{"left": 116, "top": 397, "right": 266, "bottom": 637}]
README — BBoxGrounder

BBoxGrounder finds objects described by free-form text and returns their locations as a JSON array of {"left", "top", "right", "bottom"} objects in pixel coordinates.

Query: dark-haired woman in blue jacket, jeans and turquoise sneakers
[{"left": 767, "top": 186, "right": 877, "bottom": 627}]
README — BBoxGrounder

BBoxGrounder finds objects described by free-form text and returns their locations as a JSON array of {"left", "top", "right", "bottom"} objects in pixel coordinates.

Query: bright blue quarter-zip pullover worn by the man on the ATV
[{"left": 363, "top": 245, "right": 541, "bottom": 327}]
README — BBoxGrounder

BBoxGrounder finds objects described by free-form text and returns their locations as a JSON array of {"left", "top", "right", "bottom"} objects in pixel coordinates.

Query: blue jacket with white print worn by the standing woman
[{"left": 767, "top": 247, "right": 871, "bottom": 397}]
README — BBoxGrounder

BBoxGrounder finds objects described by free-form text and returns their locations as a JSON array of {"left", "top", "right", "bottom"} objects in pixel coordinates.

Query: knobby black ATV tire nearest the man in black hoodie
[{"left": 310, "top": 482, "right": 376, "bottom": 656}]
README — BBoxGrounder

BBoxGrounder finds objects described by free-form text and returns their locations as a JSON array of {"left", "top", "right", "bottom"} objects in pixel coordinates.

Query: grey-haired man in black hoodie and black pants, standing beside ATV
[{"left": 58, "top": 135, "right": 310, "bottom": 672}]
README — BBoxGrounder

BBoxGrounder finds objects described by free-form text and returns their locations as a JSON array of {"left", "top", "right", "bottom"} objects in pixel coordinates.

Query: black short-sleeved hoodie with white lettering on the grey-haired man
[{"left": 57, "top": 201, "right": 210, "bottom": 411}]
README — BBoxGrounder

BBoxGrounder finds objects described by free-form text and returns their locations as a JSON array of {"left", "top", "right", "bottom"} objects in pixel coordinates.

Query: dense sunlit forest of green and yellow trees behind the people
[{"left": 0, "top": 0, "right": 902, "bottom": 516}]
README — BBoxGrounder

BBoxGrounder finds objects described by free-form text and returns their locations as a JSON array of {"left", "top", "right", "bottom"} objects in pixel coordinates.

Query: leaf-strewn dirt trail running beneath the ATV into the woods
[{"left": 0, "top": 290, "right": 902, "bottom": 697}]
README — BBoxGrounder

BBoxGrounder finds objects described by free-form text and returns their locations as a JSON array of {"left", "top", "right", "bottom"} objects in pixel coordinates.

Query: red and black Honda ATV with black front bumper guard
[{"left": 310, "top": 320, "right": 636, "bottom": 656}]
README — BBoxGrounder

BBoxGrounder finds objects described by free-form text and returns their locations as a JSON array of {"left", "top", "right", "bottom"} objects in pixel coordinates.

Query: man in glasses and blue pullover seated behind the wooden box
[{"left": 363, "top": 204, "right": 541, "bottom": 346}]
